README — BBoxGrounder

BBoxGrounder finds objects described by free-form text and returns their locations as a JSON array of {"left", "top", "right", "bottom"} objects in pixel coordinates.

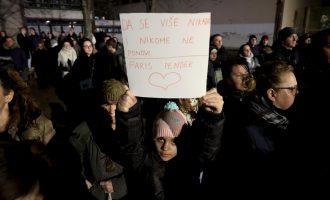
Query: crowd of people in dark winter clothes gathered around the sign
[{"left": 0, "top": 27, "right": 330, "bottom": 200}]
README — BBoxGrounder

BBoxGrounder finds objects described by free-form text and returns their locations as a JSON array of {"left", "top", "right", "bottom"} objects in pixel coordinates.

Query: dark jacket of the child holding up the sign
[{"left": 116, "top": 101, "right": 224, "bottom": 200}]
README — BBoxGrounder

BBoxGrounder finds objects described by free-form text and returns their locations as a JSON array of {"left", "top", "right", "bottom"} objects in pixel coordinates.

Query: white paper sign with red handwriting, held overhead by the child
[{"left": 120, "top": 13, "right": 211, "bottom": 98}]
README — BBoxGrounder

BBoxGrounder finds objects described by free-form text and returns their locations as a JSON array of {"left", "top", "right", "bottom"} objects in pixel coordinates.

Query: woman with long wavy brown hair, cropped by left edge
[{"left": 0, "top": 66, "right": 55, "bottom": 145}]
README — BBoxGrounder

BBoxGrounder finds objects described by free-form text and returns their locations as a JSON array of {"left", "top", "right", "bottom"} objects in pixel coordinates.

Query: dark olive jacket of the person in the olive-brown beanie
[{"left": 70, "top": 121, "right": 127, "bottom": 200}]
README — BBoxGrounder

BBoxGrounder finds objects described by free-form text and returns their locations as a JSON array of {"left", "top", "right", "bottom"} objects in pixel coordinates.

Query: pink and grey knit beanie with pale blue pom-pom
[{"left": 153, "top": 102, "right": 187, "bottom": 138}]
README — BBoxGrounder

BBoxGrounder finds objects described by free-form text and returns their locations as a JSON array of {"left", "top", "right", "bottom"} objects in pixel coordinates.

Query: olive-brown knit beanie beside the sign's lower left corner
[{"left": 102, "top": 79, "right": 127, "bottom": 102}]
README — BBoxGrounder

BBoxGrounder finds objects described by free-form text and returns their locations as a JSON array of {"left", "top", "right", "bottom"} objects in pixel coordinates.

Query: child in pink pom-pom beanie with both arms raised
[{"left": 116, "top": 89, "right": 224, "bottom": 200}]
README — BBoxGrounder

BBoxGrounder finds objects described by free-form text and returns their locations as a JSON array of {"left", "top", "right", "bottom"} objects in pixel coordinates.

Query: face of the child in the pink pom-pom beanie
[{"left": 154, "top": 137, "right": 178, "bottom": 161}]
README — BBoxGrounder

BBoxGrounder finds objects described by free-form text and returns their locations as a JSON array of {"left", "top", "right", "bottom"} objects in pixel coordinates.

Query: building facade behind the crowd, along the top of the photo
[{"left": 0, "top": 0, "right": 324, "bottom": 47}]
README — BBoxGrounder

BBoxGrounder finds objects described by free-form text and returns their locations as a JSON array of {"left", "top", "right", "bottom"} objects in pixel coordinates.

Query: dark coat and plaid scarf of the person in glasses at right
[{"left": 238, "top": 97, "right": 301, "bottom": 194}]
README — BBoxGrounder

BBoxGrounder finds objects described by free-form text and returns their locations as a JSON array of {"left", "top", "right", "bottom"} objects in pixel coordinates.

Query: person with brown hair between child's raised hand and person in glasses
[{"left": 205, "top": 62, "right": 256, "bottom": 199}]
